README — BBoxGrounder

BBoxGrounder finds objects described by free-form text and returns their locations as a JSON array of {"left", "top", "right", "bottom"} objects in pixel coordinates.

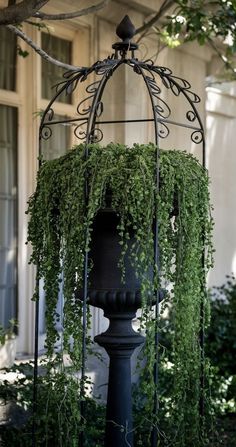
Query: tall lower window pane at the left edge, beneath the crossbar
[{"left": 0, "top": 105, "right": 17, "bottom": 327}]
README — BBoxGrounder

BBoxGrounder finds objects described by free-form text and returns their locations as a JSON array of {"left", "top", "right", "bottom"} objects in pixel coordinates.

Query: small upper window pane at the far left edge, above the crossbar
[{"left": 0, "top": 26, "right": 16, "bottom": 90}]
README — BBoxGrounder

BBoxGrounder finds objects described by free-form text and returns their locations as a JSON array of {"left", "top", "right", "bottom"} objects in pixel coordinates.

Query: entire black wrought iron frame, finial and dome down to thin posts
[{"left": 33, "top": 16, "right": 206, "bottom": 446}]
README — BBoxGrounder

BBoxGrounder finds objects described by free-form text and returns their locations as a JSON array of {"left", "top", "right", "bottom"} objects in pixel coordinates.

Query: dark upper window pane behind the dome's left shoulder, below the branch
[{"left": 42, "top": 33, "right": 72, "bottom": 104}]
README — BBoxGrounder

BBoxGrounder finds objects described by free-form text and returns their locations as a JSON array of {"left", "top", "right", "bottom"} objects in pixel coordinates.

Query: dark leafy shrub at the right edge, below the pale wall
[{"left": 206, "top": 276, "right": 236, "bottom": 413}]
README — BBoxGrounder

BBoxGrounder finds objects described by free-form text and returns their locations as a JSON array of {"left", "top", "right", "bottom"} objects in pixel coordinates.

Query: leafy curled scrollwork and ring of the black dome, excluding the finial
[{"left": 40, "top": 55, "right": 203, "bottom": 144}]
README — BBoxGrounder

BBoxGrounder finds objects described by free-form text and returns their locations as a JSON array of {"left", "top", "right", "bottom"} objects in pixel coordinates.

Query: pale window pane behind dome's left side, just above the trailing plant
[{"left": 42, "top": 115, "right": 70, "bottom": 160}]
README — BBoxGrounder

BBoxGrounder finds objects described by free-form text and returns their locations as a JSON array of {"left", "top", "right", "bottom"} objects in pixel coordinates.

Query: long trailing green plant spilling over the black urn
[{"left": 28, "top": 143, "right": 213, "bottom": 447}]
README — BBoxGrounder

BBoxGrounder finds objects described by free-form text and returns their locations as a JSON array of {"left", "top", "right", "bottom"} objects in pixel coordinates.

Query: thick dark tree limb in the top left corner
[{"left": 0, "top": 0, "right": 49, "bottom": 25}]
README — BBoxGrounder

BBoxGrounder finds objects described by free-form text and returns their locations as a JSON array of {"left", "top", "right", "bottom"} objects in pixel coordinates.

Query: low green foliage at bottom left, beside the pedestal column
[{"left": 0, "top": 361, "right": 105, "bottom": 447}]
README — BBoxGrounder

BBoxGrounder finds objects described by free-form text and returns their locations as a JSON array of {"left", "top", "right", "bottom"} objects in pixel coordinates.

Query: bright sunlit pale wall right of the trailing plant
[{"left": 206, "top": 82, "right": 236, "bottom": 286}]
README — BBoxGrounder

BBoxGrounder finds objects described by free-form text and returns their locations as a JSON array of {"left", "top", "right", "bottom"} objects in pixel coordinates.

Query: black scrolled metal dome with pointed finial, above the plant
[{"left": 39, "top": 16, "right": 205, "bottom": 165}]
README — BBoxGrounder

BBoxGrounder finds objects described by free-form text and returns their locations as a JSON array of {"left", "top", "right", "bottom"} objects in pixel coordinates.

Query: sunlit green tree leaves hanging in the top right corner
[{"left": 159, "top": 0, "right": 236, "bottom": 79}]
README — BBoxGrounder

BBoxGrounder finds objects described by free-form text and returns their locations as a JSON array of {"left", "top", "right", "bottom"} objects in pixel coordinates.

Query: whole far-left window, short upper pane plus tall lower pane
[{"left": 0, "top": 26, "right": 18, "bottom": 327}]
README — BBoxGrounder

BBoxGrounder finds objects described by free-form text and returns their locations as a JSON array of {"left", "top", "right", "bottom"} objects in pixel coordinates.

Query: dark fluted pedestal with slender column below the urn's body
[{"left": 90, "top": 291, "right": 145, "bottom": 447}]
